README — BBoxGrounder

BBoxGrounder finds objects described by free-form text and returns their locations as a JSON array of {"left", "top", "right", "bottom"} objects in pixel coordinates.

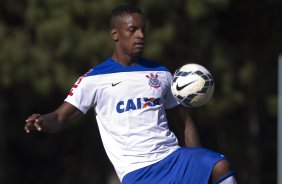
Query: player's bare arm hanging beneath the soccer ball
[{"left": 166, "top": 105, "right": 201, "bottom": 147}]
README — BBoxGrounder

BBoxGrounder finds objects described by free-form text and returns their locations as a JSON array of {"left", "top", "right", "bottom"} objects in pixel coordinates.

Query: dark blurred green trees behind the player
[{"left": 0, "top": 0, "right": 282, "bottom": 184}]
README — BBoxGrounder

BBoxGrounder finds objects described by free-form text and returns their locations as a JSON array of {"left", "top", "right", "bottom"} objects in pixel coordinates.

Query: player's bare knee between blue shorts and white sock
[{"left": 211, "top": 160, "right": 231, "bottom": 181}]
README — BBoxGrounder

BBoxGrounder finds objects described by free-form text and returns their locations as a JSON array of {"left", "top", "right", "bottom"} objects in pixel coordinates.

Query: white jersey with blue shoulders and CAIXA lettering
[{"left": 65, "top": 58, "right": 179, "bottom": 180}]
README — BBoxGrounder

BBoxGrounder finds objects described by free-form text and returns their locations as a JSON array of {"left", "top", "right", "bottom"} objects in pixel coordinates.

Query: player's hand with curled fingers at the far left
[{"left": 24, "top": 114, "right": 44, "bottom": 133}]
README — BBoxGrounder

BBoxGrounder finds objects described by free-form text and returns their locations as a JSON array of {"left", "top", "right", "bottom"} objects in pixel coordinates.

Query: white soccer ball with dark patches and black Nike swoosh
[{"left": 171, "top": 63, "right": 214, "bottom": 107}]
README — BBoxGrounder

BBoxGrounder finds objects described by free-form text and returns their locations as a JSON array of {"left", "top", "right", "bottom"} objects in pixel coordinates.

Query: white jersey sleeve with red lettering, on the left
[{"left": 65, "top": 76, "right": 95, "bottom": 114}]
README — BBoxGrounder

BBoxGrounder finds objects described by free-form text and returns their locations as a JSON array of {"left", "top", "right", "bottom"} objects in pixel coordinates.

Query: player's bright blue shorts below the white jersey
[{"left": 122, "top": 147, "right": 225, "bottom": 184}]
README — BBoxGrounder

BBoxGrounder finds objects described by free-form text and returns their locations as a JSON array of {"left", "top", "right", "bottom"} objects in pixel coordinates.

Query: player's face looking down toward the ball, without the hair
[{"left": 112, "top": 13, "right": 145, "bottom": 56}]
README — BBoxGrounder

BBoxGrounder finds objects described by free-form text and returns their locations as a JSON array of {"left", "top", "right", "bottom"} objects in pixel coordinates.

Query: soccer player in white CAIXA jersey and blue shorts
[{"left": 25, "top": 6, "right": 236, "bottom": 184}]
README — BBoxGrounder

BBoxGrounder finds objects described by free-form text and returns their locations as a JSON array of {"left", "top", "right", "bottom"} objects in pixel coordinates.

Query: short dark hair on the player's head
[{"left": 110, "top": 5, "right": 142, "bottom": 29}]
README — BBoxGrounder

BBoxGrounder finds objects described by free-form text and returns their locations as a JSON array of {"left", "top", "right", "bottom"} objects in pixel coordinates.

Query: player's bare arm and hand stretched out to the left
[{"left": 24, "top": 102, "right": 82, "bottom": 133}]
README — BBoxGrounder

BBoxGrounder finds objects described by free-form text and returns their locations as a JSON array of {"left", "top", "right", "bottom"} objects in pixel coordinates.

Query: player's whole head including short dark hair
[{"left": 110, "top": 5, "right": 146, "bottom": 56}]
